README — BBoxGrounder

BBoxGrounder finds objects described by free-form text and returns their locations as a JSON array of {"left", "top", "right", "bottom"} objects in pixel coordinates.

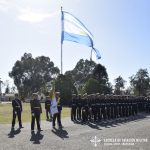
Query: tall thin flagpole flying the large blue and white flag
[{"left": 61, "top": 6, "right": 63, "bottom": 74}]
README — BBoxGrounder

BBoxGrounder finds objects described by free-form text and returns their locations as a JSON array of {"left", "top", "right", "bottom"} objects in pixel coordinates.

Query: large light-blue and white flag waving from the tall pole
[{"left": 61, "top": 11, "right": 101, "bottom": 59}]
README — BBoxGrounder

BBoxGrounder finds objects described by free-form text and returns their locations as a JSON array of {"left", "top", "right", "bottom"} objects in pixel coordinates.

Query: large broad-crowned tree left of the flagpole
[{"left": 9, "top": 53, "right": 59, "bottom": 97}]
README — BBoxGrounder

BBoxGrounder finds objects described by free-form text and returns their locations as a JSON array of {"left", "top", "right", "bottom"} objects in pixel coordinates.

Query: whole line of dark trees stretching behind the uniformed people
[{"left": 9, "top": 53, "right": 150, "bottom": 104}]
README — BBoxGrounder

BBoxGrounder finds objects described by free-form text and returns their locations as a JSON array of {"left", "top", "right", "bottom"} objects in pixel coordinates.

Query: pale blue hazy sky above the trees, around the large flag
[{"left": 0, "top": 0, "right": 150, "bottom": 91}]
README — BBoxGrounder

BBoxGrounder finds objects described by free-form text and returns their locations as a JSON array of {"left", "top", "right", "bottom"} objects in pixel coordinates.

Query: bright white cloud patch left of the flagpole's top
[{"left": 18, "top": 8, "right": 59, "bottom": 23}]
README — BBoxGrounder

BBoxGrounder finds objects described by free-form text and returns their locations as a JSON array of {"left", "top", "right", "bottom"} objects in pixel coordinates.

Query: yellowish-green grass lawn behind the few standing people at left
[{"left": 0, "top": 103, "right": 70, "bottom": 124}]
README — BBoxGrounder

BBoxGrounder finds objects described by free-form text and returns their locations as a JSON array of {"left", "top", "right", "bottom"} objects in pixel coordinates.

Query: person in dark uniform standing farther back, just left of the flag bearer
[{"left": 45, "top": 96, "right": 52, "bottom": 121}]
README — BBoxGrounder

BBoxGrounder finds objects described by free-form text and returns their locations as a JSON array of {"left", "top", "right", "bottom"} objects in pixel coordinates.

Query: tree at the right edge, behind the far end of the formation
[{"left": 129, "top": 69, "right": 150, "bottom": 96}]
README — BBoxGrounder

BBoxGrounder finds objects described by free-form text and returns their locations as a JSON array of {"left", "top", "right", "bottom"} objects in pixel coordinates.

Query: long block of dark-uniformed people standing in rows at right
[{"left": 71, "top": 93, "right": 150, "bottom": 122}]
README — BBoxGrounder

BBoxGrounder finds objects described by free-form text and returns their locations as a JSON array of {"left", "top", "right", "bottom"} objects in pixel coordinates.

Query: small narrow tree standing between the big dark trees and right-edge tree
[{"left": 114, "top": 76, "right": 126, "bottom": 95}]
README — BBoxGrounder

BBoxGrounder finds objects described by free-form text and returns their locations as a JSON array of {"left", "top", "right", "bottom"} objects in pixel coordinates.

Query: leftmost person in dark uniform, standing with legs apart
[{"left": 12, "top": 94, "right": 23, "bottom": 130}]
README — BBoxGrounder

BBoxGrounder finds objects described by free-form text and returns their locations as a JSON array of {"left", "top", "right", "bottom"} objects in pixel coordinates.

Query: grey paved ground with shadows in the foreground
[{"left": 0, "top": 114, "right": 150, "bottom": 150}]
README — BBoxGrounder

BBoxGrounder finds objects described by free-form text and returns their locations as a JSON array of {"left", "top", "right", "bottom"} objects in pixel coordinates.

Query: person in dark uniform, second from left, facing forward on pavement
[{"left": 30, "top": 93, "right": 42, "bottom": 131}]
